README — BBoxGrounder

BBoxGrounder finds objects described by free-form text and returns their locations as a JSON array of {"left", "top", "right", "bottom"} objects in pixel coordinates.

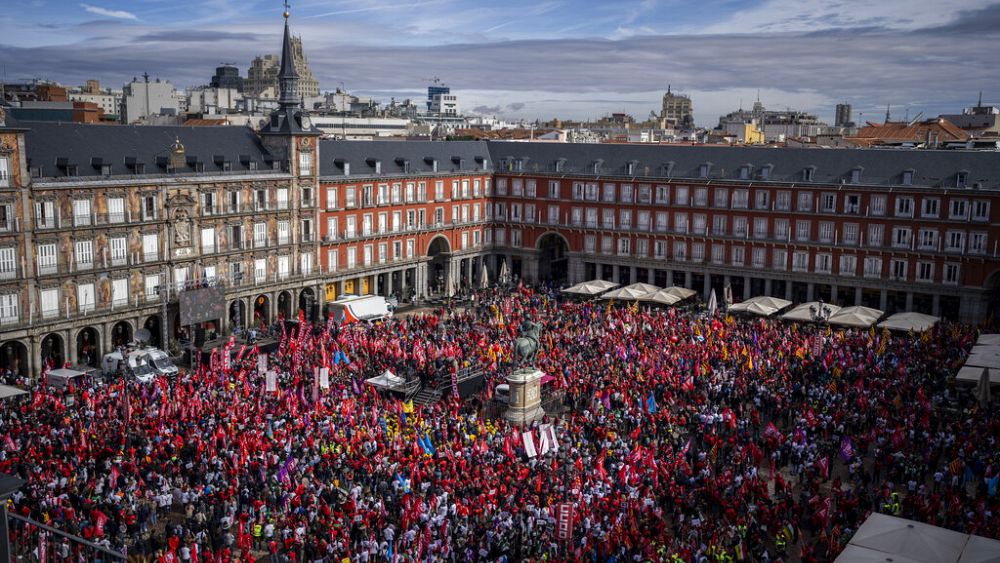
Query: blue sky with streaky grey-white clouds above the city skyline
[{"left": 0, "top": 0, "right": 1000, "bottom": 125}]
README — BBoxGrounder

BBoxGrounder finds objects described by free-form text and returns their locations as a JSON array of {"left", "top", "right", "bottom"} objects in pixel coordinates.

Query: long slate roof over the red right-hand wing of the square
[{"left": 478, "top": 141, "right": 1000, "bottom": 189}]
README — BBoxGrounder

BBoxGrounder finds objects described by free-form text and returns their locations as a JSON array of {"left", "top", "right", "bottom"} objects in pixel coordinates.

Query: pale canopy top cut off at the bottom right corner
[{"left": 836, "top": 512, "right": 1000, "bottom": 563}]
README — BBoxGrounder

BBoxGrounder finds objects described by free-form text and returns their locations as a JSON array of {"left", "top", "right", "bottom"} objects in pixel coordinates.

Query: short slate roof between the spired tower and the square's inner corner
[{"left": 319, "top": 140, "right": 494, "bottom": 178}]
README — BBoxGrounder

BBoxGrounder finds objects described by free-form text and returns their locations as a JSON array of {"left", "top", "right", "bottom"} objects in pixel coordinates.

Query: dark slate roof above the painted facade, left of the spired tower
[{"left": 26, "top": 122, "right": 273, "bottom": 179}]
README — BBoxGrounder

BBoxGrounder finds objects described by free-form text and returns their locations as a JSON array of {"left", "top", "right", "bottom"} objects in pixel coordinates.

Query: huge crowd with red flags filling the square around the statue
[{"left": 0, "top": 287, "right": 1000, "bottom": 563}]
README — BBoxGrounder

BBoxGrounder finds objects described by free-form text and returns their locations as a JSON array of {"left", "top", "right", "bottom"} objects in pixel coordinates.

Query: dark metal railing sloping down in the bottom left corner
[{"left": 0, "top": 512, "right": 127, "bottom": 563}]
